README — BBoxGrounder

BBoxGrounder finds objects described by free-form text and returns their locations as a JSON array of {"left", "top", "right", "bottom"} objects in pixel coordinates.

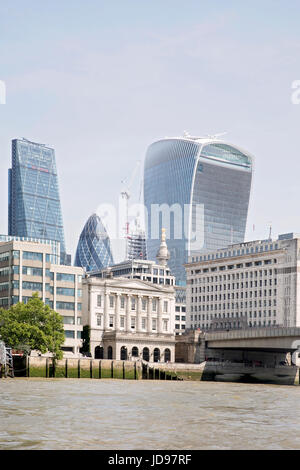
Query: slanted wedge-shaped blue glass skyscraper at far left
[{"left": 8, "top": 139, "right": 70, "bottom": 264}]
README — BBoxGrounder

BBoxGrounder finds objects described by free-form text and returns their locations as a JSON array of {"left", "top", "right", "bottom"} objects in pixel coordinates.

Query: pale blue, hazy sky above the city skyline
[{"left": 0, "top": 0, "right": 300, "bottom": 257}]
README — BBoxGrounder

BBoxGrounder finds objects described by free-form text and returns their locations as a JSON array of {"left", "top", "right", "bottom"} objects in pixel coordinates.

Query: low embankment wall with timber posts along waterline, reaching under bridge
[{"left": 7, "top": 356, "right": 299, "bottom": 385}]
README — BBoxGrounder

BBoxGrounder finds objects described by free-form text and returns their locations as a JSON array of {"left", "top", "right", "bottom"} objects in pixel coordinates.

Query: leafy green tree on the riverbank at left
[{"left": 0, "top": 292, "right": 65, "bottom": 359}]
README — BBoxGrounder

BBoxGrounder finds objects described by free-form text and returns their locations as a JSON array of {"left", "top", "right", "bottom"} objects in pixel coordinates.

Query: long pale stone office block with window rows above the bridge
[{"left": 185, "top": 233, "right": 300, "bottom": 330}]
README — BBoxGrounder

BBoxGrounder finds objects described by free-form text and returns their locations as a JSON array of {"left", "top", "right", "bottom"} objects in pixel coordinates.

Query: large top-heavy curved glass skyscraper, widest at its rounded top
[{"left": 144, "top": 136, "right": 253, "bottom": 285}]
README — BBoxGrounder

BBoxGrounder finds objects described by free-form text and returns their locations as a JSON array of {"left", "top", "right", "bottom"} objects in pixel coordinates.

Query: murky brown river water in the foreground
[{"left": 0, "top": 379, "right": 300, "bottom": 450}]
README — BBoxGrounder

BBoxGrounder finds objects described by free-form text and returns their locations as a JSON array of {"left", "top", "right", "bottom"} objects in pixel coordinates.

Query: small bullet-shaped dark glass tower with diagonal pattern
[{"left": 74, "top": 214, "right": 114, "bottom": 272}]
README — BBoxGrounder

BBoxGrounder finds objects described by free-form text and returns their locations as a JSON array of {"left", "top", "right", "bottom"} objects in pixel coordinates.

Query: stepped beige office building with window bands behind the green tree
[{"left": 0, "top": 239, "right": 84, "bottom": 354}]
